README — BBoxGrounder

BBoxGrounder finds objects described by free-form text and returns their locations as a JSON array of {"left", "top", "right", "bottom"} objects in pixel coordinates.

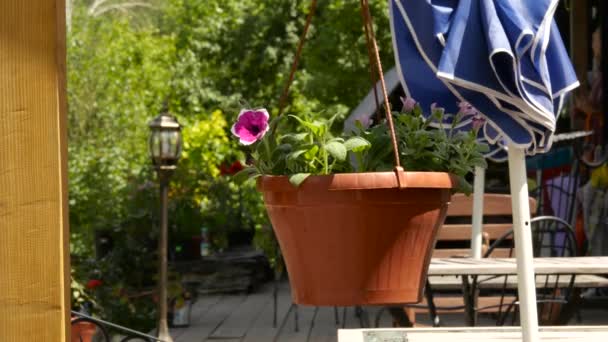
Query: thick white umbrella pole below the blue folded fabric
[{"left": 509, "top": 146, "right": 539, "bottom": 342}]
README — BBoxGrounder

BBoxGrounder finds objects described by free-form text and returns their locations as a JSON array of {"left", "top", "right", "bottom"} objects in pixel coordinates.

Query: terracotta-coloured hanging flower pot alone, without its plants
[{"left": 258, "top": 172, "right": 456, "bottom": 306}]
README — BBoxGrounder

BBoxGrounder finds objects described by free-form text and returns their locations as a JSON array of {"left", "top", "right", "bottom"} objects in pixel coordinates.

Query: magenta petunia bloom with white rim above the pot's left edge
[{"left": 231, "top": 108, "right": 270, "bottom": 145}]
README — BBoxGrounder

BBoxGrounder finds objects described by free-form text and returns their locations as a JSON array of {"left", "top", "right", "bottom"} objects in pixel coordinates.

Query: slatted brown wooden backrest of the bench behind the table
[{"left": 433, "top": 194, "right": 536, "bottom": 258}]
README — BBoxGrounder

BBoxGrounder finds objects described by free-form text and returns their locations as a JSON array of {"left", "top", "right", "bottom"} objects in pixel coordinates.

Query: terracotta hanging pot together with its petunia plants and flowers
[{"left": 232, "top": 99, "right": 485, "bottom": 305}]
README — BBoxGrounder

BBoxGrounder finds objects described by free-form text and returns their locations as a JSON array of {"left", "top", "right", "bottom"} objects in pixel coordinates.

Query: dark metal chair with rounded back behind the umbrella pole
[{"left": 474, "top": 216, "right": 578, "bottom": 325}]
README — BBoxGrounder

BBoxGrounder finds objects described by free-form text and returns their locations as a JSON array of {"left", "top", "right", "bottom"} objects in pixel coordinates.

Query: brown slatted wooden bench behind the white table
[{"left": 406, "top": 194, "right": 536, "bottom": 324}]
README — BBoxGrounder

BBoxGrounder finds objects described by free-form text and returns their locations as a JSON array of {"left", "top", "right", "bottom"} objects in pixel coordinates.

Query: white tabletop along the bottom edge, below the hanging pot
[{"left": 338, "top": 326, "right": 608, "bottom": 342}]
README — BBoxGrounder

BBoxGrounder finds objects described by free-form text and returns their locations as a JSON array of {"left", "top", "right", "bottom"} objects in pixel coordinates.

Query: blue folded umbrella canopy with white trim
[{"left": 389, "top": 0, "right": 578, "bottom": 159}]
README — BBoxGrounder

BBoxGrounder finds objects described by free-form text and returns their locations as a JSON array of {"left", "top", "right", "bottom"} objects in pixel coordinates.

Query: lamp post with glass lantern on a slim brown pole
[{"left": 148, "top": 105, "right": 182, "bottom": 342}]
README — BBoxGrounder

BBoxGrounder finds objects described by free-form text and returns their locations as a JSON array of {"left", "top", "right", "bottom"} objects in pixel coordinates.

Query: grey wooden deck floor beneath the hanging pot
[{"left": 171, "top": 283, "right": 608, "bottom": 342}]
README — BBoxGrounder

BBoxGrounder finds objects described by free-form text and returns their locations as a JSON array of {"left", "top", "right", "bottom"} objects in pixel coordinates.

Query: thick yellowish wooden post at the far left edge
[{"left": 0, "top": 0, "right": 70, "bottom": 342}]
